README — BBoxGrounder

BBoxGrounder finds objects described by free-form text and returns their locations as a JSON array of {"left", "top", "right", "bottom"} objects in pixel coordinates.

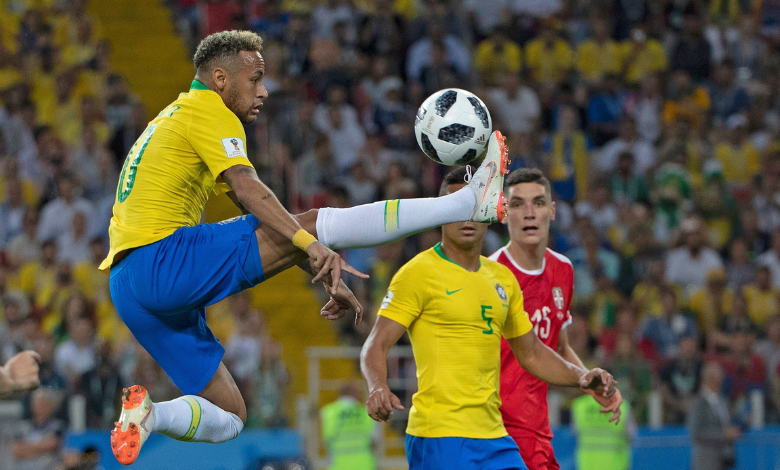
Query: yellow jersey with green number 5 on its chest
[{"left": 378, "top": 244, "right": 532, "bottom": 439}]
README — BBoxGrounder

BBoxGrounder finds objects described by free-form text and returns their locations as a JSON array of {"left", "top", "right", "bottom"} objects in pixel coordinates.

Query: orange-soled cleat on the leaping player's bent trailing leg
[{"left": 111, "top": 385, "right": 154, "bottom": 465}]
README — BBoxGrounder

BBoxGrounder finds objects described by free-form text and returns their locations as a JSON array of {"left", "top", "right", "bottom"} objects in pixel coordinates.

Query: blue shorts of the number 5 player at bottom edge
[{"left": 406, "top": 434, "right": 528, "bottom": 470}]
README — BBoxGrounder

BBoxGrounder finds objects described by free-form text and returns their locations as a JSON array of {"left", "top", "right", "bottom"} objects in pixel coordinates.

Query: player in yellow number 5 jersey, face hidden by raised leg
[{"left": 361, "top": 169, "right": 615, "bottom": 470}]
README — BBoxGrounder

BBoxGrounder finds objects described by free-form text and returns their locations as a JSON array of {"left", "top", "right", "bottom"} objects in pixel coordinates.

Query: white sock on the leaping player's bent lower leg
[{"left": 152, "top": 395, "right": 244, "bottom": 444}]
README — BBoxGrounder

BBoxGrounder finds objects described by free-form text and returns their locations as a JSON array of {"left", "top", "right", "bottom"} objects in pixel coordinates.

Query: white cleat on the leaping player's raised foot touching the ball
[{"left": 468, "top": 131, "right": 509, "bottom": 223}]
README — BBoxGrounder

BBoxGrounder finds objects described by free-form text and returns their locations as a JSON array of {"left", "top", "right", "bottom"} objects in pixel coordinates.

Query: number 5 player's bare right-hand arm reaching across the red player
[{"left": 507, "top": 330, "right": 615, "bottom": 397}]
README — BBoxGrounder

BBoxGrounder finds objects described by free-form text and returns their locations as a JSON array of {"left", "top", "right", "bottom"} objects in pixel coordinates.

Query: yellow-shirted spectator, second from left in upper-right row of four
[{"left": 525, "top": 20, "right": 572, "bottom": 83}]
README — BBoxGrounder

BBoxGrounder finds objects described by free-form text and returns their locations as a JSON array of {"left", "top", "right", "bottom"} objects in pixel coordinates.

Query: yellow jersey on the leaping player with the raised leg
[{"left": 100, "top": 80, "right": 252, "bottom": 272}]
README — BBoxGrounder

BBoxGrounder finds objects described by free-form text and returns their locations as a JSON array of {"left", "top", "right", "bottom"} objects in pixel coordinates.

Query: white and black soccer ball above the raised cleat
[{"left": 414, "top": 88, "right": 493, "bottom": 165}]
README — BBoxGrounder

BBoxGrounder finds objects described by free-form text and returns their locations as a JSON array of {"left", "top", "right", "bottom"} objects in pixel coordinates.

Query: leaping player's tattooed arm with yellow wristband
[{"left": 221, "top": 165, "right": 368, "bottom": 290}]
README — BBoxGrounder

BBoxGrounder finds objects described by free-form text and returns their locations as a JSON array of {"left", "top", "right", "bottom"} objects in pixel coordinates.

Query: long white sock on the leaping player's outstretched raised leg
[{"left": 317, "top": 188, "right": 476, "bottom": 249}]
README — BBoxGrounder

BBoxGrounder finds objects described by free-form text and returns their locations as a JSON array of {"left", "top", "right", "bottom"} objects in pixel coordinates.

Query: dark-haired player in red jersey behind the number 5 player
[{"left": 490, "top": 168, "right": 622, "bottom": 470}]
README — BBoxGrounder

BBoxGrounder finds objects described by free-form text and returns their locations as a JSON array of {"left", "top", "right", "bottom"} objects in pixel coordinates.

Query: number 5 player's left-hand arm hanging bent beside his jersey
[{"left": 360, "top": 316, "right": 406, "bottom": 421}]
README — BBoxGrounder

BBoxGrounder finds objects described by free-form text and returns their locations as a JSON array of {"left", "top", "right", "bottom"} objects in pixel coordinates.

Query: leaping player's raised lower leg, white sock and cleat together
[{"left": 314, "top": 131, "right": 509, "bottom": 249}]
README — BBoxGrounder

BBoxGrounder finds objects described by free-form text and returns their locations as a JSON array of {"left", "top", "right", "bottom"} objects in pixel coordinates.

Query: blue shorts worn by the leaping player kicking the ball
[{"left": 109, "top": 215, "right": 265, "bottom": 395}]
